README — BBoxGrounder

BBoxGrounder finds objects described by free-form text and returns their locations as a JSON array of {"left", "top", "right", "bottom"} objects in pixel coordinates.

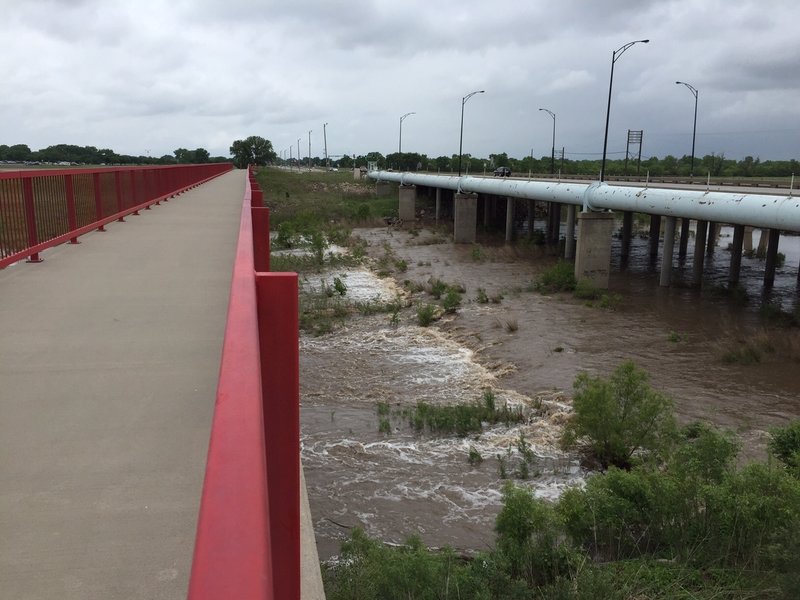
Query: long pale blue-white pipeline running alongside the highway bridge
[{"left": 367, "top": 171, "right": 800, "bottom": 232}]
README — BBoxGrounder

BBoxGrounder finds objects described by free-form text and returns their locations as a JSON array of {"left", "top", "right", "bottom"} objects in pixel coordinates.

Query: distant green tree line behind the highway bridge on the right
[{"left": 278, "top": 152, "right": 800, "bottom": 177}]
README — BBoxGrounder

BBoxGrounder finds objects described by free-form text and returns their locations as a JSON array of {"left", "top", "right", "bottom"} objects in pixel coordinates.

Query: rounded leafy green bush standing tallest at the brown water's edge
[{"left": 562, "top": 361, "right": 675, "bottom": 469}]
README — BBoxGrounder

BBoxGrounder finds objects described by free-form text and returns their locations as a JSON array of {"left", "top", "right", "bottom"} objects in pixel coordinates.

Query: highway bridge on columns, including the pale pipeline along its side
[{"left": 368, "top": 169, "right": 800, "bottom": 287}]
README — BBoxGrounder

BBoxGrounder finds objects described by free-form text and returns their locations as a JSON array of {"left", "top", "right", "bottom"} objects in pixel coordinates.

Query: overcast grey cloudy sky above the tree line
[{"left": 0, "top": 0, "right": 800, "bottom": 159}]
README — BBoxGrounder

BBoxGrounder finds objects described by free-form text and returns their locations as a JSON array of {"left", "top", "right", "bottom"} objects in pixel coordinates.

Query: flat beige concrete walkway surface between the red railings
[{"left": 0, "top": 171, "right": 245, "bottom": 600}]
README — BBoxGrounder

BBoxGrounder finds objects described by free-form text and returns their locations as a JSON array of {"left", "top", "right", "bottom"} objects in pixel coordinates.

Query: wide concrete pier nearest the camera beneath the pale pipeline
[{"left": 575, "top": 212, "right": 614, "bottom": 289}]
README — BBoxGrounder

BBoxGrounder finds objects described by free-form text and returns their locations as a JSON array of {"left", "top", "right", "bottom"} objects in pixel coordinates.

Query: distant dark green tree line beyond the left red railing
[{"left": 0, "top": 144, "right": 230, "bottom": 165}]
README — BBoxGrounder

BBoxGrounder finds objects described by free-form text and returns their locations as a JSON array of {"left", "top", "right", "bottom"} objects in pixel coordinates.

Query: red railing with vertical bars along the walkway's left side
[{"left": 0, "top": 163, "right": 233, "bottom": 269}]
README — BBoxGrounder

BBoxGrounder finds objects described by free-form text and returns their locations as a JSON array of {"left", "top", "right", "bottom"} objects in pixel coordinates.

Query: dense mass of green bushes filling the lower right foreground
[{"left": 324, "top": 363, "right": 800, "bottom": 600}]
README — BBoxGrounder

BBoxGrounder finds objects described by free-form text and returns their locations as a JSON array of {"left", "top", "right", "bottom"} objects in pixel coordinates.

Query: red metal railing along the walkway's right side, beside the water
[{"left": 189, "top": 168, "right": 300, "bottom": 600}]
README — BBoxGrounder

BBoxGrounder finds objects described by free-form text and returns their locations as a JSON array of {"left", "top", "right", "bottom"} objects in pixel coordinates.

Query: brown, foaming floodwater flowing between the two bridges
[{"left": 300, "top": 223, "right": 800, "bottom": 560}]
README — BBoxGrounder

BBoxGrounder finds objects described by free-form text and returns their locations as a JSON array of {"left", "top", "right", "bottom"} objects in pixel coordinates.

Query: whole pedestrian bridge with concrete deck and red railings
[{"left": 0, "top": 165, "right": 322, "bottom": 599}]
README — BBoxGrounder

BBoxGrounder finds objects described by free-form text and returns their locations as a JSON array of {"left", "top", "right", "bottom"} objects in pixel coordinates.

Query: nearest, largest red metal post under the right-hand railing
[{"left": 256, "top": 273, "right": 300, "bottom": 600}]
